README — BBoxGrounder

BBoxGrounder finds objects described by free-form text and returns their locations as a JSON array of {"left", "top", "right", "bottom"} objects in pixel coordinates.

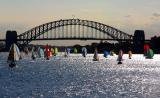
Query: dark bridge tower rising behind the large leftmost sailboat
[{"left": 5, "top": 31, "right": 17, "bottom": 51}]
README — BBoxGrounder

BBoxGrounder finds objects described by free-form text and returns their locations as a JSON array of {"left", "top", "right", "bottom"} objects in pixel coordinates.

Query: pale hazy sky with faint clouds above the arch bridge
[{"left": 0, "top": 0, "right": 160, "bottom": 38}]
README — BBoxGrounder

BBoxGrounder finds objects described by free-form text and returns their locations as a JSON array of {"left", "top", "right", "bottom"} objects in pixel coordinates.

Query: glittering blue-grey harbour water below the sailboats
[{"left": 0, "top": 53, "right": 160, "bottom": 98}]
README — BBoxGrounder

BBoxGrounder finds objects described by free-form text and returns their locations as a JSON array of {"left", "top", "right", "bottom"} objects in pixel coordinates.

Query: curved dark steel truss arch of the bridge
[{"left": 17, "top": 19, "right": 133, "bottom": 44}]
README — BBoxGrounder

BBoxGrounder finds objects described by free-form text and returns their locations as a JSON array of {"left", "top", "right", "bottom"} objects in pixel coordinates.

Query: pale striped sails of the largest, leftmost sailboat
[{"left": 8, "top": 44, "right": 20, "bottom": 61}]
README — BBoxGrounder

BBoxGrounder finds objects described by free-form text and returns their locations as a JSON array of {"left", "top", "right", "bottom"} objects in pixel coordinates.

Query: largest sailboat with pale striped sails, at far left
[{"left": 8, "top": 44, "right": 20, "bottom": 67}]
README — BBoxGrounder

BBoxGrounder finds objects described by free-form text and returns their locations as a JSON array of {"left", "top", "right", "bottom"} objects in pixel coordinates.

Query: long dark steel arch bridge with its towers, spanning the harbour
[{"left": 0, "top": 19, "right": 145, "bottom": 49}]
